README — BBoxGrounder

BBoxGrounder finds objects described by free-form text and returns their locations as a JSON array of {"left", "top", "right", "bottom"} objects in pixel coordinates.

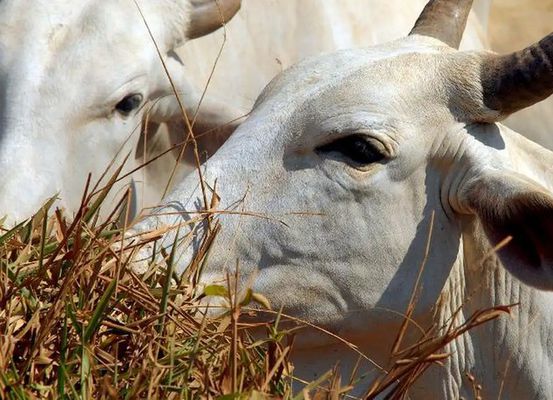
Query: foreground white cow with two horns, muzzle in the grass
[{"left": 138, "top": 0, "right": 553, "bottom": 399}]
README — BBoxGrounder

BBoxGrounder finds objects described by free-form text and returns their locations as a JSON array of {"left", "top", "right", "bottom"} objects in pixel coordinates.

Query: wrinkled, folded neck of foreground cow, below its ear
[{"left": 413, "top": 216, "right": 553, "bottom": 399}]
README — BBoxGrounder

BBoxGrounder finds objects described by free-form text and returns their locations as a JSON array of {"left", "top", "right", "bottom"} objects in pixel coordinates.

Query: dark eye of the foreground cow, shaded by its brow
[{"left": 317, "top": 135, "right": 386, "bottom": 166}]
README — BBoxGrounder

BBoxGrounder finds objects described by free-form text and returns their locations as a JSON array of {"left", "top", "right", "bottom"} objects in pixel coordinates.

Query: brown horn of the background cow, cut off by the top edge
[{"left": 186, "top": 0, "right": 241, "bottom": 39}]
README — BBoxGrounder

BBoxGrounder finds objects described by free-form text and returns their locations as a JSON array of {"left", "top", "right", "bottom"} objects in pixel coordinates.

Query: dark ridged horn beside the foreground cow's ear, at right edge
[{"left": 480, "top": 33, "right": 553, "bottom": 117}]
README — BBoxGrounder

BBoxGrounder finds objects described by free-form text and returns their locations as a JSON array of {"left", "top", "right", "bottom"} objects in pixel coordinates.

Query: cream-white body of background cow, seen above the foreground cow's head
[{"left": 178, "top": 0, "right": 491, "bottom": 112}]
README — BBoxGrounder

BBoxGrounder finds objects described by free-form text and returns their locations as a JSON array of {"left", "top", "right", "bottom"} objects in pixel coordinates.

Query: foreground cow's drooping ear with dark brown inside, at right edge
[{"left": 460, "top": 171, "right": 553, "bottom": 290}]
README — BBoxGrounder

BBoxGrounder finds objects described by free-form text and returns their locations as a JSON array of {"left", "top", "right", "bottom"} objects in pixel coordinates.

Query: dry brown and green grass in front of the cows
[{"left": 0, "top": 167, "right": 509, "bottom": 399}]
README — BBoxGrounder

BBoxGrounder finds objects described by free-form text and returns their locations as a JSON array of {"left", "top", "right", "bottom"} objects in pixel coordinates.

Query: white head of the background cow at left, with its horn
[{"left": 0, "top": 0, "right": 240, "bottom": 220}]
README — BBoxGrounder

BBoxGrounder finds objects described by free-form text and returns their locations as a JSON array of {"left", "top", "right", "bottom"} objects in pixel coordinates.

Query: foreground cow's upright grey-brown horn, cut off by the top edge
[{"left": 409, "top": 0, "right": 473, "bottom": 49}]
